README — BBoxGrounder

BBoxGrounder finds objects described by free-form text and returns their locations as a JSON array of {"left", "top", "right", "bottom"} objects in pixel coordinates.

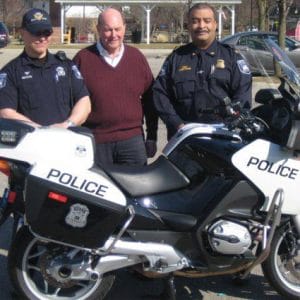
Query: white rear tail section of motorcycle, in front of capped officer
[{"left": 0, "top": 127, "right": 94, "bottom": 169}]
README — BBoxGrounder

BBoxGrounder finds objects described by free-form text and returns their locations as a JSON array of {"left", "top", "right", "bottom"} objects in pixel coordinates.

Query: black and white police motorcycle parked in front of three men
[{"left": 0, "top": 41, "right": 300, "bottom": 300}]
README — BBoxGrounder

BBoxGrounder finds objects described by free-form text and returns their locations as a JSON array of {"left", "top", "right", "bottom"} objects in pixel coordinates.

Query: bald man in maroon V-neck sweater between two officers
[{"left": 74, "top": 8, "right": 158, "bottom": 165}]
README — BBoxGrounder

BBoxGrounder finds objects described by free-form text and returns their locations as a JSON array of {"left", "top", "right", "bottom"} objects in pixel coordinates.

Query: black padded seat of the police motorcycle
[{"left": 105, "top": 156, "right": 190, "bottom": 197}]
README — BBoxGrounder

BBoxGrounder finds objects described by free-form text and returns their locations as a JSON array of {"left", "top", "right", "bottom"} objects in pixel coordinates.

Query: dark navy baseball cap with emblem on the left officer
[{"left": 22, "top": 8, "right": 53, "bottom": 36}]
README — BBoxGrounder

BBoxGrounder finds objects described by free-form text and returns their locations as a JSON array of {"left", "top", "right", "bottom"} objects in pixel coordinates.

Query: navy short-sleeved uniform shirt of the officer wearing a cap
[{"left": 0, "top": 51, "right": 89, "bottom": 126}]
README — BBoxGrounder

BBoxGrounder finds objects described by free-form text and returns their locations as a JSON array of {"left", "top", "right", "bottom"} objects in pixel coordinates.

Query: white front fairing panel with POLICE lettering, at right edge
[{"left": 232, "top": 139, "right": 300, "bottom": 215}]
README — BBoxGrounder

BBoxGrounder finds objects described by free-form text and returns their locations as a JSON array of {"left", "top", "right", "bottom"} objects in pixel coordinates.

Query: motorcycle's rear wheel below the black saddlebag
[{"left": 8, "top": 227, "right": 115, "bottom": 300}]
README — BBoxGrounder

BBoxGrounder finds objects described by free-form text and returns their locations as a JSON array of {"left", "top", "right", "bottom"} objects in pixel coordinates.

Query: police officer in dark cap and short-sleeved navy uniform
[{"left": 0, "top": 9, "right": 91, "bottom": 128}]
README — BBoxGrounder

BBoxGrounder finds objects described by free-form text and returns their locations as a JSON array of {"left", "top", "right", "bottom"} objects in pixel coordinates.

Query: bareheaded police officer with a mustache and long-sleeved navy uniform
[{"left": 153, "top": 3, "right": 252, "bottom": 139}]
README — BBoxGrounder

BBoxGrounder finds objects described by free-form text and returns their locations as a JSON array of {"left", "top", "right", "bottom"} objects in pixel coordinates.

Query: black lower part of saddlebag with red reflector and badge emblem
[{"left": 25, "top": 175, "right": 128, "bottom": 249}]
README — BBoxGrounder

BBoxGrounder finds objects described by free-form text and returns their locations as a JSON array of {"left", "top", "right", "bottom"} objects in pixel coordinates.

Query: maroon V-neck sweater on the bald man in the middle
[{"left": 74, "top": 44, "right": 158, "bottom": 143}]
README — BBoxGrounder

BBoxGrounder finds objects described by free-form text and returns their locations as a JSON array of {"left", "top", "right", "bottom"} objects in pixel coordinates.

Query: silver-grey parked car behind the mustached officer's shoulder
[{"left": 221, "top": 31, "right": 300, "bottom": 75}]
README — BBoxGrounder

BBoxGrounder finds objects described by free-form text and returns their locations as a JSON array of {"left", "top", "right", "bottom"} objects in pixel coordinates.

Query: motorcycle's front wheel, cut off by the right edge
[{"left": 262, "top": 226, "right": 300, "bottom": 300}]
